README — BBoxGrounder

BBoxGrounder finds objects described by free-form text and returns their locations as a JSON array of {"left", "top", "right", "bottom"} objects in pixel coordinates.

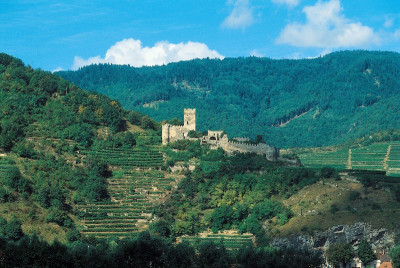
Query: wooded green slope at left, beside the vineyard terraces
[{"left": 0, "top": 53, "right": 163, "bottom": 241}]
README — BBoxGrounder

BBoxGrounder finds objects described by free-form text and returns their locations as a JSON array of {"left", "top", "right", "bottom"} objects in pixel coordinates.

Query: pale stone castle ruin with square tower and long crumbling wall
[{"left": 162, "top": 109, "right": 279, "bottom": 161}]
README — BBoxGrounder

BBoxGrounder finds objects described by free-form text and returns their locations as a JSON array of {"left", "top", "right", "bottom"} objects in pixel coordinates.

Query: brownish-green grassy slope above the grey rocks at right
[{"left": 273, "top": 179, "right": 400, "bottom": 235}]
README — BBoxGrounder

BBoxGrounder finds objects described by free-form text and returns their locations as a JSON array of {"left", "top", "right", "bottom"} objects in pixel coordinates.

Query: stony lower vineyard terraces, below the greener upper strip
[{"left": 78, "top": 170, "right": 176, "bottom": 237}]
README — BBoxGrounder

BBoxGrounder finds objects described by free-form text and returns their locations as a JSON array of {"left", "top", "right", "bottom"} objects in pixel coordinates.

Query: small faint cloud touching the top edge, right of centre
[{"left": 222, "top": 0, "right": 254, "bottom": 29}]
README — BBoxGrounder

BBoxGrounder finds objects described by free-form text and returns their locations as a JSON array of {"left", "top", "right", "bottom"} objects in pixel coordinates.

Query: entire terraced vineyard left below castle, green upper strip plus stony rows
[{"left": 78, "top": 148, "right": 176, "bottom": 237}]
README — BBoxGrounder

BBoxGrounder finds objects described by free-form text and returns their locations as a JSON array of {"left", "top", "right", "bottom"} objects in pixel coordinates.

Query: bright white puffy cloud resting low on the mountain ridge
[{"left": 72, "top": 38, "right": 224, "bottom": 70}]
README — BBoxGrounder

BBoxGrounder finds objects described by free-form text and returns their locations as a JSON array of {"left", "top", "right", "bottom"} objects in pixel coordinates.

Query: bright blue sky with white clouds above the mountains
[{"left": 0, "top": 0, "right": 400, "bottom": 71}]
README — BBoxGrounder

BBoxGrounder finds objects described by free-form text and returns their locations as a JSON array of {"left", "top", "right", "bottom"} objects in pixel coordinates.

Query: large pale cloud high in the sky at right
[{"left": 276, "top": 0, "right": 380, "bottom": 48}]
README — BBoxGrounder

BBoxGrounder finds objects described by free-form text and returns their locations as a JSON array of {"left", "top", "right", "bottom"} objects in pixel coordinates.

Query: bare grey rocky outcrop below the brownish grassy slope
[{"left": 272, "top": 222, "right": 395, "bottom": 251}]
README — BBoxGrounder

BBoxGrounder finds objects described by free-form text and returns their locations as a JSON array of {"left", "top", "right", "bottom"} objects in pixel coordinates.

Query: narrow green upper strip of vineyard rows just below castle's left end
[{"left": 81, "top": 147, "right": 164, "bottom": 168}]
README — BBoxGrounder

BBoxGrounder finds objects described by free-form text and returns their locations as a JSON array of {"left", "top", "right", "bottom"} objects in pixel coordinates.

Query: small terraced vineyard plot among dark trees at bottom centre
[{"left": 182, "top": 234, "right": 253, "bottom": 250}]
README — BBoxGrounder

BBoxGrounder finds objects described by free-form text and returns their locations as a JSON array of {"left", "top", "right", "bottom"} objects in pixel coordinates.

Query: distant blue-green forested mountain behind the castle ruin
[{"left": 58, "top": 51, "right": 400, "bottom": 147}]
